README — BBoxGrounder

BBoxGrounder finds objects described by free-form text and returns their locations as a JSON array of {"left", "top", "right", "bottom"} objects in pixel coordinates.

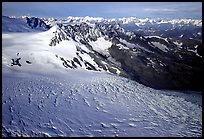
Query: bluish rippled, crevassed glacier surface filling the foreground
[{"left": 2, "top": 71, "right": 202, "bottom": 136}]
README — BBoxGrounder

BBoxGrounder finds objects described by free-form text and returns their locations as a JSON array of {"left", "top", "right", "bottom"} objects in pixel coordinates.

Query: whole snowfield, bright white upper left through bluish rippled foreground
[{"left": 2, "top": 32, "right": 202, "bottom": 137}]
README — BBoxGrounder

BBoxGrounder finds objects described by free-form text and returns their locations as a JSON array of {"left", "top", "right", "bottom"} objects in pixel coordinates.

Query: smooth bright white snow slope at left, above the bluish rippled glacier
[{"left": 2, "top": 26, "right": 99, "bottom": 72}]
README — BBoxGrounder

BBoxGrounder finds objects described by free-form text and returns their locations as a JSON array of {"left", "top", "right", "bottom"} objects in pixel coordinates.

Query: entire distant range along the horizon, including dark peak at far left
[{"left": 3, "top": 16, "right": 202, "bottom": 40}]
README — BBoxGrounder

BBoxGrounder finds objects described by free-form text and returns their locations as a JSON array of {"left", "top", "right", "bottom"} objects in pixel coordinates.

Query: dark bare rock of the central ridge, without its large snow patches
[{"left": 47, "top": 23, "right": 202, "bottom": 90}]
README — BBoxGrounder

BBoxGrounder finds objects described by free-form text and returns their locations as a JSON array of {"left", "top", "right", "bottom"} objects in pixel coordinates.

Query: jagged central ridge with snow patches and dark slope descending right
[{"left": 1, "top": 15, "right": 202, "bottom": 90}]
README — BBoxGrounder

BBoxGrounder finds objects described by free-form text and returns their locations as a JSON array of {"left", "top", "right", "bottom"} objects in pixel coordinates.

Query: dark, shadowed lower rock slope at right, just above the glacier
[{"left": 109, "top": 45, "right": 202, "bottom": 90}]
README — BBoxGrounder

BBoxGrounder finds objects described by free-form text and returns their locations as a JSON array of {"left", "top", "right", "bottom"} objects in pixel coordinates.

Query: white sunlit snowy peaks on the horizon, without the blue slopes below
[{"left": 61, "top": 16, "right": 202, "bottom": 28}]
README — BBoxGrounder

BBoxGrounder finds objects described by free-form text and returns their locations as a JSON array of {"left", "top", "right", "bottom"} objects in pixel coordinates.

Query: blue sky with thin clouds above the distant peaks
[{"left": 2, "top": 2, "right": 202, "bottom": 19}]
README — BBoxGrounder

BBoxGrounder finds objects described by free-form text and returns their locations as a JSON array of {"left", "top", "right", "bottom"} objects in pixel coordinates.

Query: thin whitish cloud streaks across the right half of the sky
[{"left": 104, "top": 2, "right": 202, "bottom": 18}]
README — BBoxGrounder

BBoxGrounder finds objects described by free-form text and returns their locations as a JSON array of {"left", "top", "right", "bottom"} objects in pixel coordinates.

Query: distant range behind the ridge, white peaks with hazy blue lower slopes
[{"left": 60, "top": 16, "right": 202, "bottom": 40}]
